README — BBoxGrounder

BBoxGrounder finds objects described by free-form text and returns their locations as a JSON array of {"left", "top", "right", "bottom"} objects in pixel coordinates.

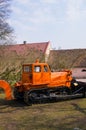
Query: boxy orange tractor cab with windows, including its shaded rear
[{"left": 22, "top": 63, "right": 51, "bottom": 85}]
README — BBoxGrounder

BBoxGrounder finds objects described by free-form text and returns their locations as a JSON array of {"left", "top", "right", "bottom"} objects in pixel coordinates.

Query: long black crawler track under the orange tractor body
[{"left": 24, "top": 88, "right": 86, "bottom": 105}]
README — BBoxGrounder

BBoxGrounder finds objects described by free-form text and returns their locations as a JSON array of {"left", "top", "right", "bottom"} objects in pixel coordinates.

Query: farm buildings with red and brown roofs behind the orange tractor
[{"left": 0, "top": 41, "right": 86, "bottom": 78}]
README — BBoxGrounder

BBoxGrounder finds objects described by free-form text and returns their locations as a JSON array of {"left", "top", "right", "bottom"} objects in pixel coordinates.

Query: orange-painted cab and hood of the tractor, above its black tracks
[{"left": 15, "top": 59, "right": 72, "bottom": 91}]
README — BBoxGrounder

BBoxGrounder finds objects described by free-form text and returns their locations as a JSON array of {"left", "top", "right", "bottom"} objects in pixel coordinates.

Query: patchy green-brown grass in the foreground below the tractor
[{"left": 0, "top": 94, "right": 86, "bottom": 130}]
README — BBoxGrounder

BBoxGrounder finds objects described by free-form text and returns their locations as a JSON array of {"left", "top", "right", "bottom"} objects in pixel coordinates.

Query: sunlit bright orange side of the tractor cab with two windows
[{"left": 33, "top": 64, "right": 51, "bottom": 85}]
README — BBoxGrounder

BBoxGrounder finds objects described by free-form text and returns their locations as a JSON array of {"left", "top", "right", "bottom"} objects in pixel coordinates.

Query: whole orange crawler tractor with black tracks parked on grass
[{"left": 13, "top": 61, "right": 86, "bottom": 105}]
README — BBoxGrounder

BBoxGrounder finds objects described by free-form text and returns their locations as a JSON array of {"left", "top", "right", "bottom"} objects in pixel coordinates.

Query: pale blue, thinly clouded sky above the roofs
[{"left": 9, "top": 0, "right": 86, "bottom": 49}]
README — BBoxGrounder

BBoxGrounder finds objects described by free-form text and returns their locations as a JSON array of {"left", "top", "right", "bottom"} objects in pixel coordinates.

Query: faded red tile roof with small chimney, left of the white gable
[{"left": 2, "top": 41, "right": 50, "bottom": 55}]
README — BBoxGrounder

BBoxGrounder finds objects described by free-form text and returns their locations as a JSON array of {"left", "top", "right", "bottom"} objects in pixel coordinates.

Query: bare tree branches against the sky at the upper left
[{"left": 0, "top": 0, "right": 13, "bottom": 44}]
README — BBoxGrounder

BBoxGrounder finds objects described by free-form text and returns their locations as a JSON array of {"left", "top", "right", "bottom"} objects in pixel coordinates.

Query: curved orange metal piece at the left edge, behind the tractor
[{"left": 0, "top": 80, "right": 13, "bottom": 100}]
